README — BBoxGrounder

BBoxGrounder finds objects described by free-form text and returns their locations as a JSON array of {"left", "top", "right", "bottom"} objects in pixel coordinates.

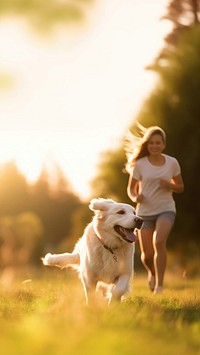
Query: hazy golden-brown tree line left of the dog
[{"left": 0, "top": 162, "right": 90, "bottom": 266}]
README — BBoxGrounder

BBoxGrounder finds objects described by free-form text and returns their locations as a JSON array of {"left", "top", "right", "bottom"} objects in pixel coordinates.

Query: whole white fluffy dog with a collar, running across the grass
[{"left": 42, "top": 198, "right": 143, "bottom": 303}]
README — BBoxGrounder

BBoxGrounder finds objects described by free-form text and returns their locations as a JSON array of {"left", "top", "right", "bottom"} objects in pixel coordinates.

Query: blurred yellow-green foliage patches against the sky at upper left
[{"left": 0, "top": 0, "right": 94, "bottom": 91}]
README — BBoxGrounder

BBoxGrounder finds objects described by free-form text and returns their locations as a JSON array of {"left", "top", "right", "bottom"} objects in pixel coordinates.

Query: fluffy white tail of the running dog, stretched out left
[{"left": 42, "top": 252, "right": 80, "bottom": 269}]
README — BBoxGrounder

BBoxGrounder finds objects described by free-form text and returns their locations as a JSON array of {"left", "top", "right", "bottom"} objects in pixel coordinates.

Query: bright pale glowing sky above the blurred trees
[{"left": 0, "top": 0, "right": 169, "bottom": 199}]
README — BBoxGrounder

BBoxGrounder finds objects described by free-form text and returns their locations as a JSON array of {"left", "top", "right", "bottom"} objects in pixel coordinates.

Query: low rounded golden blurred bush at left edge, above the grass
[{"left": 0, "top": 212, "right": 43, "bottom": 268}]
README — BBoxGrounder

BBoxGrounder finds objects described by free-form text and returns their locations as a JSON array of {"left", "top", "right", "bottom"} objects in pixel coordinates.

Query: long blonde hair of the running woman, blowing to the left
[{"left": 125, "top": 122, "right": 166, "bottom": 173}]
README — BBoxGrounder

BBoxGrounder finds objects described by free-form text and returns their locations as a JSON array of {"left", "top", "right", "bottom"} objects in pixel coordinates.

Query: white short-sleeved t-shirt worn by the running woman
[{"left": 132, "top": 154, "right": 181, "bottom": 216}]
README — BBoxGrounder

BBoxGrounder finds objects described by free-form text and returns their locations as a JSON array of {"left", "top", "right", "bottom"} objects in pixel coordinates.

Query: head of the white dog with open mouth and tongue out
[{"left": 89, "top": 198, "right": 143, "bottom": 243}]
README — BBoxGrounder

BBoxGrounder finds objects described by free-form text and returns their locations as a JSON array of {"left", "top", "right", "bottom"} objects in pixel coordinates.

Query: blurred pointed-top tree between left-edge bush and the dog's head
[{"left": 32, "top": 165, "right": 81, "bottom": 248}]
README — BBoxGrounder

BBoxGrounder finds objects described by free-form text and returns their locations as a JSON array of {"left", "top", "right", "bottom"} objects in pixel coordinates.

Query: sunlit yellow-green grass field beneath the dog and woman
[{"left": 0, "top": 269, "right": 200, "bottom": 355}]
